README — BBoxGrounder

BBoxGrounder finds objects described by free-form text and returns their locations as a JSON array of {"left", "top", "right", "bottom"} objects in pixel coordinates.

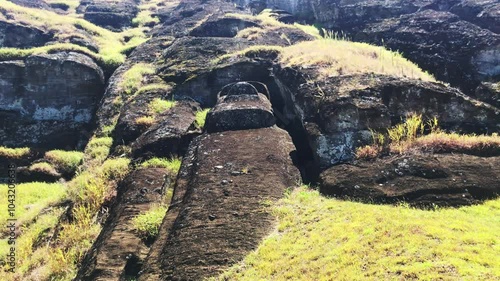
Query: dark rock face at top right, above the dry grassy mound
[{"left": 256, "top": 0, "right": 500, "bottom": 94}]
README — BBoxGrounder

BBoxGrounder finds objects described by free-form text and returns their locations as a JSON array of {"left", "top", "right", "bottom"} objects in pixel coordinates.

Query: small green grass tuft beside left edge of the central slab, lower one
[{"left": 132, "top": 202, "right": 168, "bottom": 240}]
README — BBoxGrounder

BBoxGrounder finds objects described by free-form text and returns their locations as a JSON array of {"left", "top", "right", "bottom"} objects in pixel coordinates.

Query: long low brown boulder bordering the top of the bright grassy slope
[{"left": 320, "top": 154, "right": 500, "bottom": 206}]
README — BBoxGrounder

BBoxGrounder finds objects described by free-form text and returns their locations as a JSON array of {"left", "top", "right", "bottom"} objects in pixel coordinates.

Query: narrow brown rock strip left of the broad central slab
[{"left": 75, "top": 168, "right": 168, "bottom": 281}]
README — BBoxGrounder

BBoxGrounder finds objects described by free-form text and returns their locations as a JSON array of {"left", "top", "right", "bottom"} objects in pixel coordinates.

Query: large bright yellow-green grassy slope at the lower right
[{"left": 217, "top": 187, "right": 500, "bottom": 281}]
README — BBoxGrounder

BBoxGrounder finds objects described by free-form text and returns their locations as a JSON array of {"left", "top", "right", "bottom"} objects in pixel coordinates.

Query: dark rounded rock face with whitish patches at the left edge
[{"left": 0, "top": 53, "right": 104, "bottom": 147}]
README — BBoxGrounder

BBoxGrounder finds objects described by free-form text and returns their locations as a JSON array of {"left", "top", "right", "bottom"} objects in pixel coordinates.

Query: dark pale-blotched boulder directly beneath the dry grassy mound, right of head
[{"left": 277, "top": 69, "right": 500, "bottom": 170}]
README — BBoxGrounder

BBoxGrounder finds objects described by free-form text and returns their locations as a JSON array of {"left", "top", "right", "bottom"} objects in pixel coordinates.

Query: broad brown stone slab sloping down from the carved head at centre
[{"left": 139, "top": 127, "right": 298, "bottom": 280}]
